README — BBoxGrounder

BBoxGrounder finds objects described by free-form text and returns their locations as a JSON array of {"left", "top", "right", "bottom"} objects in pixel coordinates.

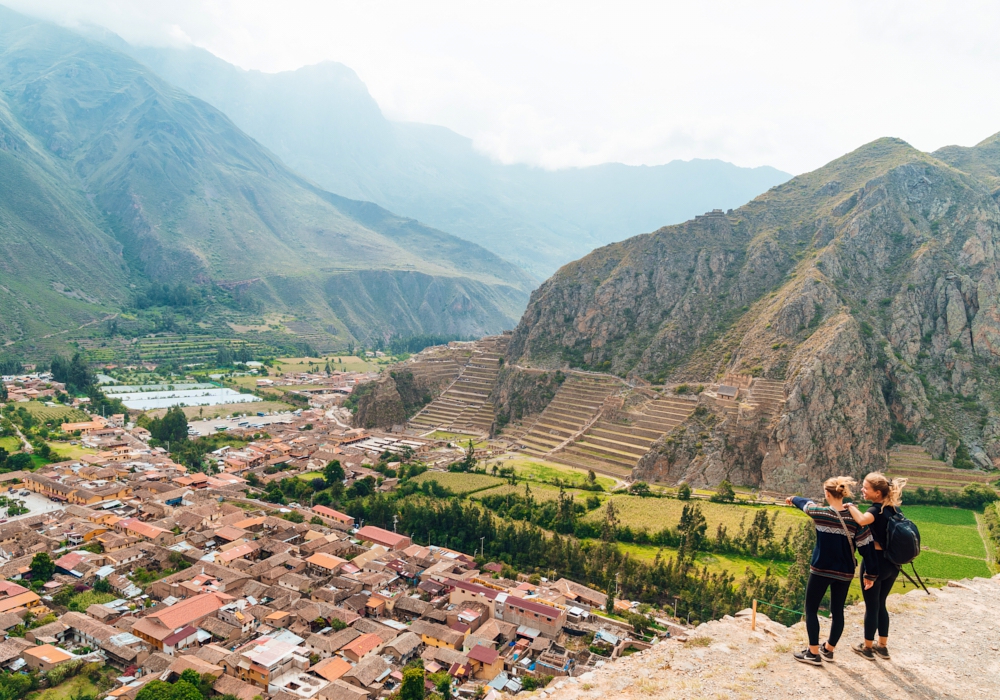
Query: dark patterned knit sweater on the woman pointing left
[{"left": 792, "top": 497, "right": 878, "bottom": 581}]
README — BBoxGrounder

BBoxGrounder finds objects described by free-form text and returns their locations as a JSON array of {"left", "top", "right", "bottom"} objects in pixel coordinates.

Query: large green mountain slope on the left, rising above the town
[{"left": 0, "top": 9, "right": 533, "bottom": 356}]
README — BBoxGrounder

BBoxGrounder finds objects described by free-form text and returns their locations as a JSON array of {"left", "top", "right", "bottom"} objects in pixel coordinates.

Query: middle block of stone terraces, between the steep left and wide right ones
[{"left": 518, "top": 374, "right": 623, "bottom": 457}]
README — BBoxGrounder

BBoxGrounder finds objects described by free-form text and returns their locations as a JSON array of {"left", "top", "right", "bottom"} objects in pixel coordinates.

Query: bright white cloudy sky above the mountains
[{"left": 11, "top": 0, "right": 1000, "bottom": 173}]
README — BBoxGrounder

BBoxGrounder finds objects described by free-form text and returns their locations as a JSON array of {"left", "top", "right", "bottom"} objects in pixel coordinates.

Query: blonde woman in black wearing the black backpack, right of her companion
[{"left": 847, "top": 472, "right": 906, "bottom": 661}]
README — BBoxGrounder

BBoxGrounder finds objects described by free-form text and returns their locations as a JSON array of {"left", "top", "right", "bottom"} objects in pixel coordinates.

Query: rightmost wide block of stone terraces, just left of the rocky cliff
[{"left": 548, "top": 395, "right": 698, "bottom": 478}]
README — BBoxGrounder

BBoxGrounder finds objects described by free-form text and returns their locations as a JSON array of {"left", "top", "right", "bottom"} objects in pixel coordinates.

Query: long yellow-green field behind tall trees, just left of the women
[{"left": 584, "top": 495, "right": 808, "bottom": 539}]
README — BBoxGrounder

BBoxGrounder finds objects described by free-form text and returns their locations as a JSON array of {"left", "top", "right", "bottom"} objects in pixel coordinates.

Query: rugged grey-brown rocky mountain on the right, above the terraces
[{"left": 508, "top": 138, "right": 1000, "bottom": 490}]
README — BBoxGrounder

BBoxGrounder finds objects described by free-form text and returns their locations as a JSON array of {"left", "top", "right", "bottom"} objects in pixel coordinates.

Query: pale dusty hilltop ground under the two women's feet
[{"left": 544, "top": 576, "right": 1000, "bottom": 700}]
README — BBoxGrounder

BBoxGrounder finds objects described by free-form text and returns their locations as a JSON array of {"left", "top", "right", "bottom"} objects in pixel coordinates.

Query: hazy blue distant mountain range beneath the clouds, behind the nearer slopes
[{"left": 115, "top": 36, "right": 789, "bottom": 277}]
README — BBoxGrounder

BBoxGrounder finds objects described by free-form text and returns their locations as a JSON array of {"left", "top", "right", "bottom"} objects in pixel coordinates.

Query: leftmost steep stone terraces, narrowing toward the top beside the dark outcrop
[{"left": 409, "top": 335, "right": 510, "bottom": 435}]
